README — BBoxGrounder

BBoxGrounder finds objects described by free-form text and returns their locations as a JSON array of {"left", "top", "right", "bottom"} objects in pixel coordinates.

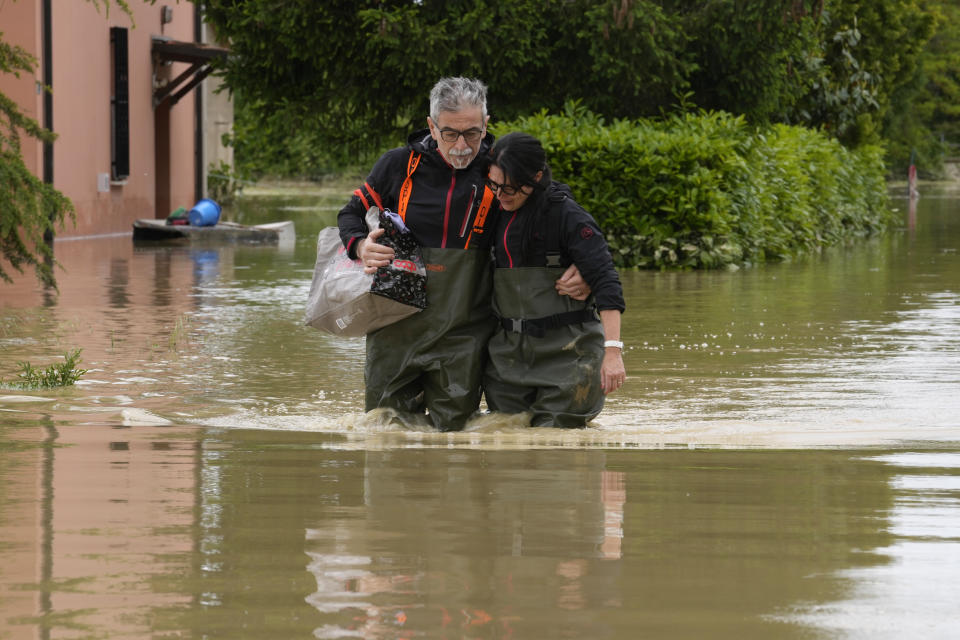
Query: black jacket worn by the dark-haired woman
[{"left": 494, "top": 182, "right": 626, "bottom": 311}]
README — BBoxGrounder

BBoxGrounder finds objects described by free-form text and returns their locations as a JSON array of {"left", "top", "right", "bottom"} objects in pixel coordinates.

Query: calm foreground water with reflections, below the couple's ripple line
[{"left": 0, "top": 419, "right": 960, "bottom": 639}]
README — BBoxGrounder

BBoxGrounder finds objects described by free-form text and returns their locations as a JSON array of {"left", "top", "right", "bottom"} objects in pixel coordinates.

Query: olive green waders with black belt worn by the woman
[{"left": 483, "top": 267, "right": 604, "bottom": 427}]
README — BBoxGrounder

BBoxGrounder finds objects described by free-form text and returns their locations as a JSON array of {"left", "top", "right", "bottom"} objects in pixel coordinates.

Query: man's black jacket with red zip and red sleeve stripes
[{"left": 337, "top": 129, "right": 496, "bottom": 257}]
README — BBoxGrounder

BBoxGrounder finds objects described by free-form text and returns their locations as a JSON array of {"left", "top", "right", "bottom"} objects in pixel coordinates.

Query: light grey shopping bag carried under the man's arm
[{"left": 304, "top": 207, "right": 426, "bottom": 337}]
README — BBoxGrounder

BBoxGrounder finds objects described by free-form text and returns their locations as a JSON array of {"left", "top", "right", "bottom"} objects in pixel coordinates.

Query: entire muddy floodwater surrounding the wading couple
[{"left": 0, "top": 182, "right": 960, "bottom": 639}]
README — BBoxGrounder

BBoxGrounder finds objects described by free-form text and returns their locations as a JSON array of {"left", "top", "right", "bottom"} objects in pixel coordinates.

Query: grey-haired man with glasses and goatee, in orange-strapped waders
[{"left": 337, "top": 78, "right": 584, "bottom": 431}]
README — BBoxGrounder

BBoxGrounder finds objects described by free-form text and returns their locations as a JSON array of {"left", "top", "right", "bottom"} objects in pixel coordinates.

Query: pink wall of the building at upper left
[{"left": 0, "top": 0, "right": 196, "bottom": 238}]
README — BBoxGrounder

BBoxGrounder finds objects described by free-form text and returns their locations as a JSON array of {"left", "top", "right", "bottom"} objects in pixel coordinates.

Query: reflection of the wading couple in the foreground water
[{"left": 306, "top": 452, "right": 626, "bottom": 638}]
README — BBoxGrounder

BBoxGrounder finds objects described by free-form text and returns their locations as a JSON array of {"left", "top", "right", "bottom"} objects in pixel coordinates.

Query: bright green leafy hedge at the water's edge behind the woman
[{"left": 491, "top": 103, "right": 893, "bottom": 268}]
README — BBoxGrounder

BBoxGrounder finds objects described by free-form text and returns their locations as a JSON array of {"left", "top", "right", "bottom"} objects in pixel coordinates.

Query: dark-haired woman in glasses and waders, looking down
[{"left": 484, "top": 133, "right": 626, "bottom": 427}]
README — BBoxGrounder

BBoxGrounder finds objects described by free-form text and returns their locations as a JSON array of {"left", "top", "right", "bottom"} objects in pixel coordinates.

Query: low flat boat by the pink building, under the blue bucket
[{"left": 133, "top": 218, "right": 296, "bottom": 245}]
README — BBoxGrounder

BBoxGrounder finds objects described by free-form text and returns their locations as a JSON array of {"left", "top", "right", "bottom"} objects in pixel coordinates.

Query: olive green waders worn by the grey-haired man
[{"left": 364, "top": 247, "right": 495, "bottom": 431}]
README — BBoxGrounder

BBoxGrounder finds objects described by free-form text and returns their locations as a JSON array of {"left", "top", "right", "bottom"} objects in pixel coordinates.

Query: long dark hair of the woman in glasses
[{"left": 489, "top": 131, "right": 553, "bottom": 256}]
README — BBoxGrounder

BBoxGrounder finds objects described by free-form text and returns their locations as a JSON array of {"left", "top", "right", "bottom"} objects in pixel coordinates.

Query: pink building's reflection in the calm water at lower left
[{"left": 0, "top": 421, "right": 193, "bottom": 638}]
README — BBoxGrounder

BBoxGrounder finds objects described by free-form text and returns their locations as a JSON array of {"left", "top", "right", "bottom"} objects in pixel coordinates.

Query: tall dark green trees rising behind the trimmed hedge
[{"left": 205, "top": 0, "right": 958, "bottom": 177}]
